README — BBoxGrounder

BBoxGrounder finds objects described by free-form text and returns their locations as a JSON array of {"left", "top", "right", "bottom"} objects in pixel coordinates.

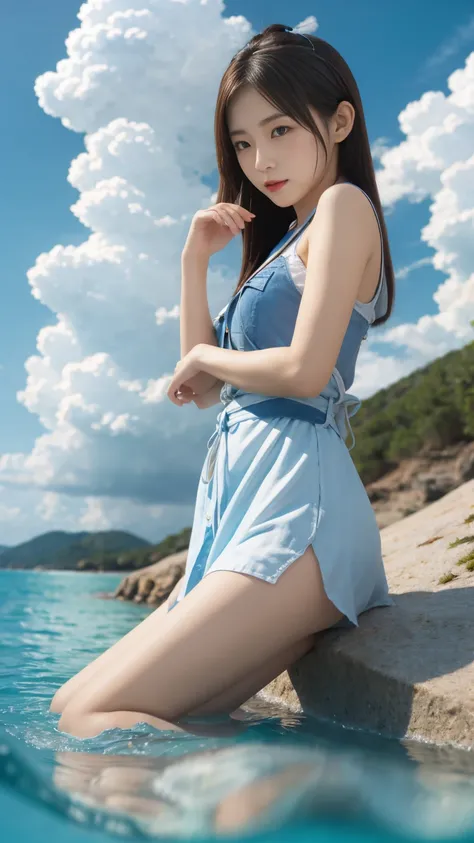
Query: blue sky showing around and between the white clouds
[{"left": 0, "top": 0, "right": 474, "bottom": 544}]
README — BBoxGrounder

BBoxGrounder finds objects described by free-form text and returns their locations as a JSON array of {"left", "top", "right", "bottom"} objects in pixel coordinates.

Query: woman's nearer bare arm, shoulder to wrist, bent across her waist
[{"left": 194, "top": 184, "right": 373, "bottom": 398}]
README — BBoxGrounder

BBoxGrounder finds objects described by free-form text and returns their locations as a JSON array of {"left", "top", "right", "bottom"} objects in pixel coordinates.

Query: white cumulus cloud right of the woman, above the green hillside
[{"left": 351, "top": 53, "right": 474, "bottom": 397}]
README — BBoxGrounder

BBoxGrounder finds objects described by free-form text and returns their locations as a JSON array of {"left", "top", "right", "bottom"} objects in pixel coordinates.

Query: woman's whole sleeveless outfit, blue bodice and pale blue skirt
[{"left": 169, "top": 186, "right": 393, "bottom": 626}]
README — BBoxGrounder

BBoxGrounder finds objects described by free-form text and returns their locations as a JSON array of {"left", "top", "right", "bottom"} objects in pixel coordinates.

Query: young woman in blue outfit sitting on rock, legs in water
[{"left": 51, "top": 24, "right": 394, "bottom": 737}]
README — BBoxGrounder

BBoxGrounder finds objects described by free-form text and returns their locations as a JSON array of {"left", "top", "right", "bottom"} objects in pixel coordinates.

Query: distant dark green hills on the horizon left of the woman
[{"left": 0, "top": 528, "right": 191, "bottom": 572}]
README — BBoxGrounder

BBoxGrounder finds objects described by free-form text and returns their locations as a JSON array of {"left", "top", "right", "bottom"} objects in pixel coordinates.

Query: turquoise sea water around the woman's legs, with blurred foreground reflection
[{"left": 0, "top": 571, "right": 474, "bottom": 843}]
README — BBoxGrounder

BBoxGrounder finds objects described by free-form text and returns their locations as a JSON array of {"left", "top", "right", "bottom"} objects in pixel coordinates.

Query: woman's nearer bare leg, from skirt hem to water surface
[{"left": 59, "top": 545, "right": 342, "bottom": 737}]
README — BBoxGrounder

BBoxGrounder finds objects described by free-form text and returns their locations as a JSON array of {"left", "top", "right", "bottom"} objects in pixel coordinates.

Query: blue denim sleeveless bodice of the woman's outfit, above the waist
[{"left": 214, "top": 185, "right": 387, "bottom": 448}]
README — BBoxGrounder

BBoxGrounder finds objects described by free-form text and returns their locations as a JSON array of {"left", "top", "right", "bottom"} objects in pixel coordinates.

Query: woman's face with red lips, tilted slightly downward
[{"left": 228, "top": 86, "right": 331, "bottom": 207}]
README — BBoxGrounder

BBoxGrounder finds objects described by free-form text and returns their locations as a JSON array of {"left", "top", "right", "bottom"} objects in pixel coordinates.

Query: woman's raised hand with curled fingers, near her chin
[{"left": 183, "top": 202, "right": 255, "bottom": 258}]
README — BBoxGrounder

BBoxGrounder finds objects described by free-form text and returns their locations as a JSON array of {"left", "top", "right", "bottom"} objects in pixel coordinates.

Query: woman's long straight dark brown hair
[{"left": 214, "top": 23, "right": 395, "bottom": 325}]
